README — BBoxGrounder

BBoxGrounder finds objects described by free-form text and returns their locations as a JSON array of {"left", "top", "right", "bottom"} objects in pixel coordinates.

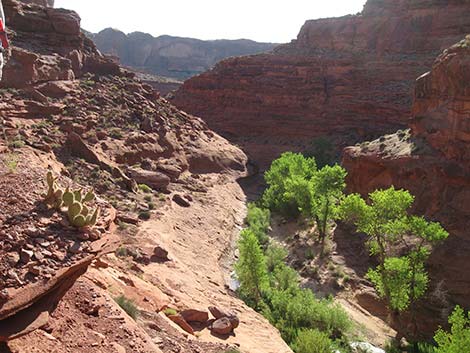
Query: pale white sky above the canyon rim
[{"left": 55, "top": 0, "right": 365, "bottom": 43}]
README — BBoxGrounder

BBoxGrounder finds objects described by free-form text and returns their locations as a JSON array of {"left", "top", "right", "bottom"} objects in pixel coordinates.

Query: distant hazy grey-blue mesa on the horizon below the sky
[{"left": 89, "top": 28, "right": 275, "bottom": 80}]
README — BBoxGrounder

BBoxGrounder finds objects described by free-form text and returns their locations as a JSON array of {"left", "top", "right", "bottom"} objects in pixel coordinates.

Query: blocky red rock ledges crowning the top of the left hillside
[{"left": 2, "top": 0, "right": 120, "bottom": 88}]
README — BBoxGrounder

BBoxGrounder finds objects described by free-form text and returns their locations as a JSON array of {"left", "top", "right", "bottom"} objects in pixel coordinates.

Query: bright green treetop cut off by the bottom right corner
[{"left": 434, "top": 306, "right": 470, "bottom": 353}]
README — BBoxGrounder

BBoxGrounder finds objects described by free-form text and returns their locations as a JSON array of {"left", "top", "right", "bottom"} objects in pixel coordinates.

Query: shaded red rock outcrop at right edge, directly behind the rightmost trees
[{"left": 343, "top": 36, "right": 470, "bottom": 334}]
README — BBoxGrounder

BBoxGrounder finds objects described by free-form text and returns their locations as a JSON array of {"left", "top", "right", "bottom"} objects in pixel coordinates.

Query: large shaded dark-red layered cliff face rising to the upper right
[{"left": 173, "top": 0, "right": 470, "bottom": 166}]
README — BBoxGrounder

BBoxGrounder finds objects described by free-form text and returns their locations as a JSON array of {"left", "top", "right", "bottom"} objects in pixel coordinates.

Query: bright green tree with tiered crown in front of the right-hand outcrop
[{"left": 339, "top": 187, "right": 448, "bottom": 312}]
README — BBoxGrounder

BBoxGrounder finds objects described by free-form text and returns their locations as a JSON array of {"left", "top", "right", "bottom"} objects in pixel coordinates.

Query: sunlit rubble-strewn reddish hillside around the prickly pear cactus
[{"left": 0, "top": 0, "right": 290, "bottom": 353}]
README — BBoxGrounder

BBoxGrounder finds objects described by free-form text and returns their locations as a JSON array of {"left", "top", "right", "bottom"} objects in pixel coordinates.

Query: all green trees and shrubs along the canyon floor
[{"left": 236, "top": 152, "right": 452, "bottom": 353}]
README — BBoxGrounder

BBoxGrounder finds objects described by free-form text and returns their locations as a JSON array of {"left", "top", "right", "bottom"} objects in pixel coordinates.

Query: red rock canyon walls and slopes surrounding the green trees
[{"left": 0, "top": 0, "right": 470, "bottom": 353}]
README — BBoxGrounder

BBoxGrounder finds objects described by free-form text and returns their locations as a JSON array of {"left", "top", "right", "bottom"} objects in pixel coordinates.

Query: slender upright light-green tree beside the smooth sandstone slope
[{"left": 235, "top": 229, "right": 269, "bottom": 306}]
